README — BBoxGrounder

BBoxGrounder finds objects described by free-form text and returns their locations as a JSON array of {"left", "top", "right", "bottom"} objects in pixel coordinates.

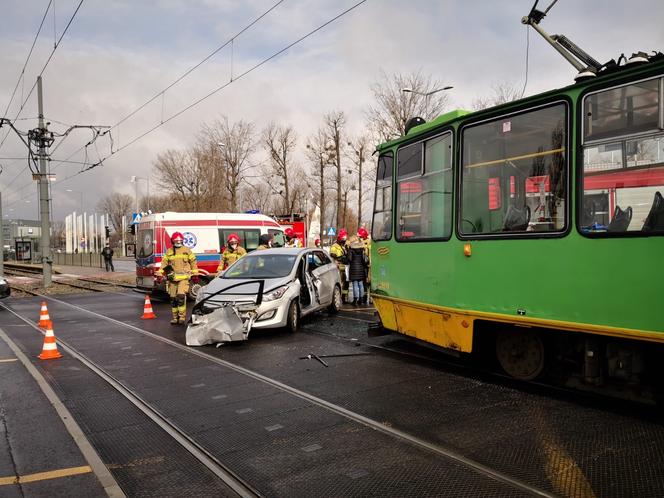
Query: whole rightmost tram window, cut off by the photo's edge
[{"left": 578, "top": 78, "right": 664, "bottom": 236}]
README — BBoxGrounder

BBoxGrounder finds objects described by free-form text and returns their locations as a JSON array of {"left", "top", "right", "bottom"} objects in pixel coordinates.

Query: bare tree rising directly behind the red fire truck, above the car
[{"left": 261, "top": 122, "right": 297, "bottom": 213}]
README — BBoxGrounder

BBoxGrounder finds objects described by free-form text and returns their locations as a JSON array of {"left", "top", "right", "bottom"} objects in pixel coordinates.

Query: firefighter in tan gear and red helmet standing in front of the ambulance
[{"left": 157, "top": 232, "right": 198, "bottom": 325}]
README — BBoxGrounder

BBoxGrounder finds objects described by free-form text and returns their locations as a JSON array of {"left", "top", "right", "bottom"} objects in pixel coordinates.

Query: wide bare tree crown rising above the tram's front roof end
[{"left": 366, "top": 71, "right": 448, "bottom": 142}]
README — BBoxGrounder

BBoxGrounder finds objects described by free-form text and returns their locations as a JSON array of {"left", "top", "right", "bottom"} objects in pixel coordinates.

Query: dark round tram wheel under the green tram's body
[{"left": 496, "top": 330, "right": 546, "bottom": 380}]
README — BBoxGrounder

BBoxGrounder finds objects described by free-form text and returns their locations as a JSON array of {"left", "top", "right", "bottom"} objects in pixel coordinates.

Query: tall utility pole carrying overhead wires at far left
[{"left": 36, "top": 76, "right": 53, "bottom": 288}]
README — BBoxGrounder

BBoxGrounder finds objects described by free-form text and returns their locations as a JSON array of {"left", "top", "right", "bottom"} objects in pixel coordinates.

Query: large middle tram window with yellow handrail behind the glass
[{"left": 459, "top": 104, "right": 568, "bottom": 236}]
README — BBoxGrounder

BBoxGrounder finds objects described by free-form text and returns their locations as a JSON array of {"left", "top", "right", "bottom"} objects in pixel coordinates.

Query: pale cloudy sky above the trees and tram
[{"left": 0, "top": 0, "right": 664, "bottom": 220}]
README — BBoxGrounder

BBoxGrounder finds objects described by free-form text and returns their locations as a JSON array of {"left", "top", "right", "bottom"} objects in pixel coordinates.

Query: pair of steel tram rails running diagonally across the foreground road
[{"left": 0, "top": 296, "right": 552, "bottom": 496}]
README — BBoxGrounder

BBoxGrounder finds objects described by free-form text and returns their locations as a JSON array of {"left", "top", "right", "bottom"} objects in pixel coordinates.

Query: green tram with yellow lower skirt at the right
[{"left": 371, "top": 54, "right": 664, "bottom": 394}]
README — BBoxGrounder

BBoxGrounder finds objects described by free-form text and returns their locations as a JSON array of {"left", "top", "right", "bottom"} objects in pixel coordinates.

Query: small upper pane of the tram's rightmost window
[{"left": 583, "top": 79, "right": 661, "bottom": 142}]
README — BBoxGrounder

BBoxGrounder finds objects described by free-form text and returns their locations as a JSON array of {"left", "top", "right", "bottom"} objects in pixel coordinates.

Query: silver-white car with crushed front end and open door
[{"left": 186, "top": 248, "right": 342, "bottom": 346}]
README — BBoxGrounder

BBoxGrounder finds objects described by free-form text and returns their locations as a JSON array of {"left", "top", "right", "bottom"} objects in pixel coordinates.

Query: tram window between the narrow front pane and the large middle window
[{"left": 397, "top": 133, "right": 453, "bottom": 240}]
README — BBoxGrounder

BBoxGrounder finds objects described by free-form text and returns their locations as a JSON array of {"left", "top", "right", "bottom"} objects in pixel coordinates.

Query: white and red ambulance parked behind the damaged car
[{"left": 136, "top": 212, "right": 285, "bottom": 298}]
